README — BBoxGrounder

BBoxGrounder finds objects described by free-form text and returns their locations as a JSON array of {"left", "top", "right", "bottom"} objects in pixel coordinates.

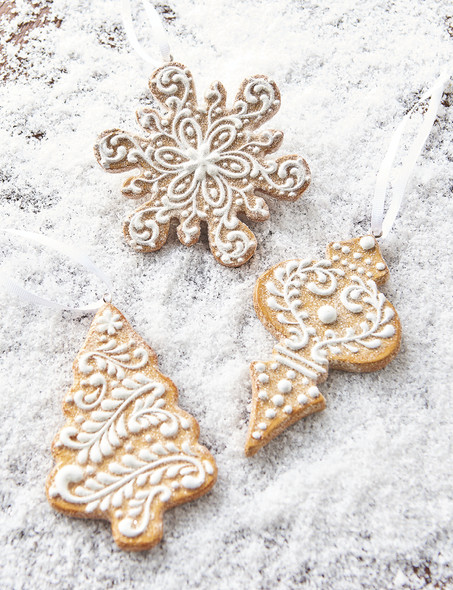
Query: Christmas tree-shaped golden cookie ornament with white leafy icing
[{"left": 47, "top": 304, "right": 217, "bottom": 550}]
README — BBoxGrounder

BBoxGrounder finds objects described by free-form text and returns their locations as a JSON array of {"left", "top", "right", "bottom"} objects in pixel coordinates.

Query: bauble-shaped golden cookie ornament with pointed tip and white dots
[{"left": 245, "top": 236, "right": 401, "bottom": 455}]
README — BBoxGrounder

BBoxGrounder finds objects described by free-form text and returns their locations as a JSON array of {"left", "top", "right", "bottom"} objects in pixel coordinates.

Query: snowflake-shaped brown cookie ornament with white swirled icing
[{"left": 95, "top": 63, "right": 310, "bottom": 266}]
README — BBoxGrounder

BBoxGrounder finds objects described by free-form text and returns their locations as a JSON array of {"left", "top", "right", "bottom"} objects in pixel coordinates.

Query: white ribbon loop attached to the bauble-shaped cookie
[{"left": 371, "top": 70, "right": 451, "bottom": 238}]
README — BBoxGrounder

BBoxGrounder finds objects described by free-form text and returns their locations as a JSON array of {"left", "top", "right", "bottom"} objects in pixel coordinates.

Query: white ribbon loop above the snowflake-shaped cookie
[{"left": 121, "top": 0, "right": 173, "bottom": 67}]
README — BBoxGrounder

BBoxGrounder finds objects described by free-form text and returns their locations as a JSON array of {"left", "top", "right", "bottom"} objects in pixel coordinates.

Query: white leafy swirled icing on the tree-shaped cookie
[{"left": 49, "top": 307, "right": 215, "bottom": 538}]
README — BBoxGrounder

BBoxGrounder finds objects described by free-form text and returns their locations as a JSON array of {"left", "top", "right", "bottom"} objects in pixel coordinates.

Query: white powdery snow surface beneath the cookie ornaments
[{"left": 0, "top": 0, "right": 453, "bottom": 590}]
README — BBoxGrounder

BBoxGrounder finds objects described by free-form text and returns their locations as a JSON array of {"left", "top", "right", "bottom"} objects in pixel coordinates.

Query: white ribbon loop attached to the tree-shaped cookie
[{"left": 0, "top": 229, "right": 112, "bottom": 311}]
